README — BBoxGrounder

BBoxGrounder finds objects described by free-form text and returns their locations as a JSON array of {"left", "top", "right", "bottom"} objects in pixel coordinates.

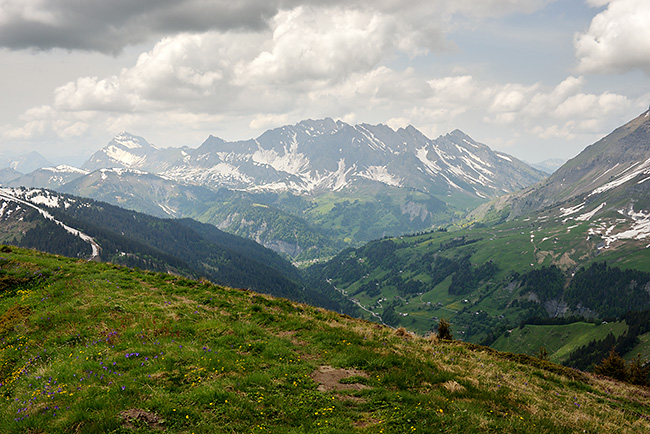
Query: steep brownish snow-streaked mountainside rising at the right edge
[{"left": 471, "top": 111, "right": 650, "bottom": 225}]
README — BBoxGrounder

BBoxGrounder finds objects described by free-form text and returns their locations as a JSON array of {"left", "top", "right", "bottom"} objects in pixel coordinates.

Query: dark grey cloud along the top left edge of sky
[{"left": 0, "top": 0, "right": 279, "bottom": 53}]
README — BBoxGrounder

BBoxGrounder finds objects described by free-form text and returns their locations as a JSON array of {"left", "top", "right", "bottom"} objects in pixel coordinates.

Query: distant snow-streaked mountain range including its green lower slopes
[{"left": 0, "top": 119, "right": 545, "bottom": 260}]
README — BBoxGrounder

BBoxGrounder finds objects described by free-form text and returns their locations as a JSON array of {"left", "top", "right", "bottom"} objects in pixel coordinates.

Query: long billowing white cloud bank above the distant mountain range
[{"left": 50, "top": 7, "right": 408, "bottom": 112}]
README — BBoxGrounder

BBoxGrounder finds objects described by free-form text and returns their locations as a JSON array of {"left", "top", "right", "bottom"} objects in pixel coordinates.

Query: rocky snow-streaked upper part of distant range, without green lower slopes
[{"left": 83, "top": 118, "right": 544, "bottom": 198}]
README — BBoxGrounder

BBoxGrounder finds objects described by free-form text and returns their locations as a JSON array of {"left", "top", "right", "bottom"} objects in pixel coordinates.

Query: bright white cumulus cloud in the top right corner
[{"left": 574, "top": 0, "right": 650, "bottom": 74}]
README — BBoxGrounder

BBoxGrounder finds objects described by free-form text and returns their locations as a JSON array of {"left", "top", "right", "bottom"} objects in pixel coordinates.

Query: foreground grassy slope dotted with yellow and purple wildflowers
[{"left": 0, "top": 248, "right": 650, "bottom": 433}]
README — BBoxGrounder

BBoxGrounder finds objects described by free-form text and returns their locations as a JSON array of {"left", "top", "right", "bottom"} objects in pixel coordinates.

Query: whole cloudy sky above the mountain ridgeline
[{"left": 0, "top": 0, "right": 650, "bottom": 165}]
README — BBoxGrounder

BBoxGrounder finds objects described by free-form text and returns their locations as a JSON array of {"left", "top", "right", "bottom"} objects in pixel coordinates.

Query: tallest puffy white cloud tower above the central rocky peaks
[{"left": 236, "top": 7, "right": 390, "bottom": 84}]
